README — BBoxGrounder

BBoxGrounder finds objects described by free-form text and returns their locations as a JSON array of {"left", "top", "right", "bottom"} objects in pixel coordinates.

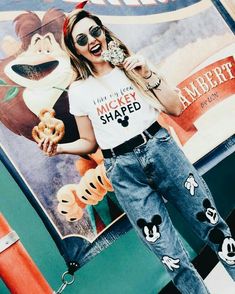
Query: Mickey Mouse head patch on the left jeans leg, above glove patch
[{"left": 137, "top": 214, "right": 162, "bottom": 243}]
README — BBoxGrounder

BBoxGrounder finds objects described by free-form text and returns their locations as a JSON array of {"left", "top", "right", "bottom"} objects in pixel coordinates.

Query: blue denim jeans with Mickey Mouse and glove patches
[{"left": 105, "top": 128, "right": 235, "bottom": 294}]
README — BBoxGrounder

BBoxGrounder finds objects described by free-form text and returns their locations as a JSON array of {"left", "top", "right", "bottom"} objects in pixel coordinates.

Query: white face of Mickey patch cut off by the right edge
[{"left": 218, "top": 237, "right": 235, "bottom": 265}]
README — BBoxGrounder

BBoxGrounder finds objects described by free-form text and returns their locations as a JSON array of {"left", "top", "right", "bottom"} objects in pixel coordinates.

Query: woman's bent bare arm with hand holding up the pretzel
[{"left": 39, "top": 116, "right": 98, "bottom": 156}]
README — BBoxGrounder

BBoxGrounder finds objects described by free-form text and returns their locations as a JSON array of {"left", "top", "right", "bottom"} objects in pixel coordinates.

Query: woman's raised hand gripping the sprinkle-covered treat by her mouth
[{"left": 123, "top": 54, "right": 151, "bottom": 78}]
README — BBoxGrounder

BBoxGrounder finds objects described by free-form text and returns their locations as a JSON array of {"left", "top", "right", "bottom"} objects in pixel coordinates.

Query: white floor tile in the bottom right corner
[{"left": 205, "top": 262, "right": 235, "bottom": 294}]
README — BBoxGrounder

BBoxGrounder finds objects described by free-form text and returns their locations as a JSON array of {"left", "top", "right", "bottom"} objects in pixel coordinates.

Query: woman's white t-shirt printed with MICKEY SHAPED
[{"left": 69, "top": 67, "right": 158, "bottom": 149}]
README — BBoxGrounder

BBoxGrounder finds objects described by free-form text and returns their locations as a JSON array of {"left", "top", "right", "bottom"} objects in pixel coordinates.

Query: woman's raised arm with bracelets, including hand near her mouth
[{"left": 123, "top": 55, "right": 183, "bottom": 116}]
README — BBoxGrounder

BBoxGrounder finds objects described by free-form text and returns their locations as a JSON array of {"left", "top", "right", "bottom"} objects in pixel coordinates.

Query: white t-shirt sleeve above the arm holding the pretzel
[{"left": 68, "top": 84, "right": 88, "bottom": 116}]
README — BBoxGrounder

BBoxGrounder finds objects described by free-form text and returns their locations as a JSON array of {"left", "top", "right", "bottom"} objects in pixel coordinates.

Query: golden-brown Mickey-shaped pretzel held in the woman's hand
[{"left": 32, "top": 108, "right": 65, "bottom": 144}]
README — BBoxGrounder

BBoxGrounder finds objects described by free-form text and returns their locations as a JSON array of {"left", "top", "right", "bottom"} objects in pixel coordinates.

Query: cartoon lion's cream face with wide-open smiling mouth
[{"left": 5, "top": 33, "right": 72, "bottom": 89}]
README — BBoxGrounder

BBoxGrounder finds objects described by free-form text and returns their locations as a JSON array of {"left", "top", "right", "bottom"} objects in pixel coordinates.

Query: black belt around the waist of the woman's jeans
[{"left": 101, "top": 122, "right": 161, "bottom": 158}]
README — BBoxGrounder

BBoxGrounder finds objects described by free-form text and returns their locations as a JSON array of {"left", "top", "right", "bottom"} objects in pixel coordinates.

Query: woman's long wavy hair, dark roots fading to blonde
[{"left": 63, "top": 9, "right": 163, "bottom": 110}]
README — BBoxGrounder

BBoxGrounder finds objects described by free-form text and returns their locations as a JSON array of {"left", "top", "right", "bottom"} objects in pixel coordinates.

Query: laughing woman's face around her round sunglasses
[{"left": 72, "top": 17, "right": 107, "bottom": 66}]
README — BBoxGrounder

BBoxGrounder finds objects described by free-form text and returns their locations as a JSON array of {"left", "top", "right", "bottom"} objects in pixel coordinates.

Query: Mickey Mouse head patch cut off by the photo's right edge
[{"left": 209, "top": 228, "right": 235, "bottom": 265}]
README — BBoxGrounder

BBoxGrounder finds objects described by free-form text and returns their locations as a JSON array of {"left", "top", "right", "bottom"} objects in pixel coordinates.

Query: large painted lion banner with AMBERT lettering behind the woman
[{"left": 0, "top": 0, "right": 235, "bottom": 271}]
